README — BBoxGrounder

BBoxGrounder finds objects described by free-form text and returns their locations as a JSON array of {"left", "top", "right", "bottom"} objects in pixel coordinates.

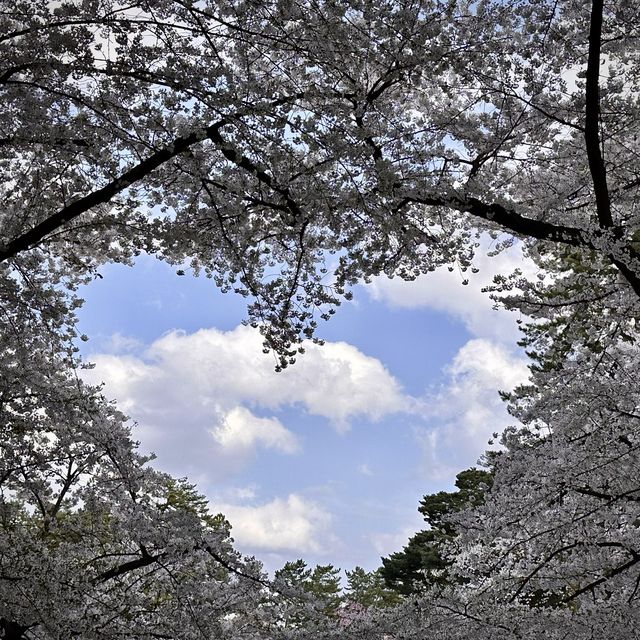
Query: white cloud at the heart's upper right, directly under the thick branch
[{"left": 367, "top": 241, "right": 538, "bottom": 343}]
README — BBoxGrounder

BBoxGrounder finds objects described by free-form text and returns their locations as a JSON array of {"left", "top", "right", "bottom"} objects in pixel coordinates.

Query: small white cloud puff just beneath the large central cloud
[{"left": 211, "top": 407, "right": 300, "bottom": 454}]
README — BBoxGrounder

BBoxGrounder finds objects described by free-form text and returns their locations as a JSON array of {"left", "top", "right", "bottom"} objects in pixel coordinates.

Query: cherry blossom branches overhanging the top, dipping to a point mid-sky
[{"left": 0, "top": 0, "right": 640, "bottom": 364}]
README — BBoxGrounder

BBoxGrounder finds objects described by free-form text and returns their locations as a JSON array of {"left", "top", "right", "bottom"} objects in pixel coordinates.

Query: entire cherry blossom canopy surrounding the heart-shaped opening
[{"left": 0, "top": 0, "right": 640, "bottom": 640}]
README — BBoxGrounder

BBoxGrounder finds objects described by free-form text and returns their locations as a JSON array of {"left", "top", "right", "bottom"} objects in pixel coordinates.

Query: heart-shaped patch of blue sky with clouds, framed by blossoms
[{"left": 79, "top": 236, "right": 534, "bottom": 572}]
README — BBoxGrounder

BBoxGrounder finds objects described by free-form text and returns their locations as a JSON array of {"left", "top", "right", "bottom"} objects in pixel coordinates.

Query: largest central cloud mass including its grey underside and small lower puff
[{"left": 85, "top": 326, "right": 412, "bottom": 477}]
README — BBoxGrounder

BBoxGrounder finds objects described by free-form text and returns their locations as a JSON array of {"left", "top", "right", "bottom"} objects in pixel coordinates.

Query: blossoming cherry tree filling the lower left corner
[{"left": 0, "top": 310, "right": 282, "bottom": 640}]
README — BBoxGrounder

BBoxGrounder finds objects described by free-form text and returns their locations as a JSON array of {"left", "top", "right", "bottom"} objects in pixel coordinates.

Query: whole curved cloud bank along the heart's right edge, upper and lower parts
[{"left": 369, "top": 237, "right": 540, "bottom": 481}]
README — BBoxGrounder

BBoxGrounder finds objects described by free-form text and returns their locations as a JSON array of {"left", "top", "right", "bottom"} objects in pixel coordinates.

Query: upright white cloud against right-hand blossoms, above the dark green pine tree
[{"left": 417, "top": 338, "right": 529, "bottom": 480}]
